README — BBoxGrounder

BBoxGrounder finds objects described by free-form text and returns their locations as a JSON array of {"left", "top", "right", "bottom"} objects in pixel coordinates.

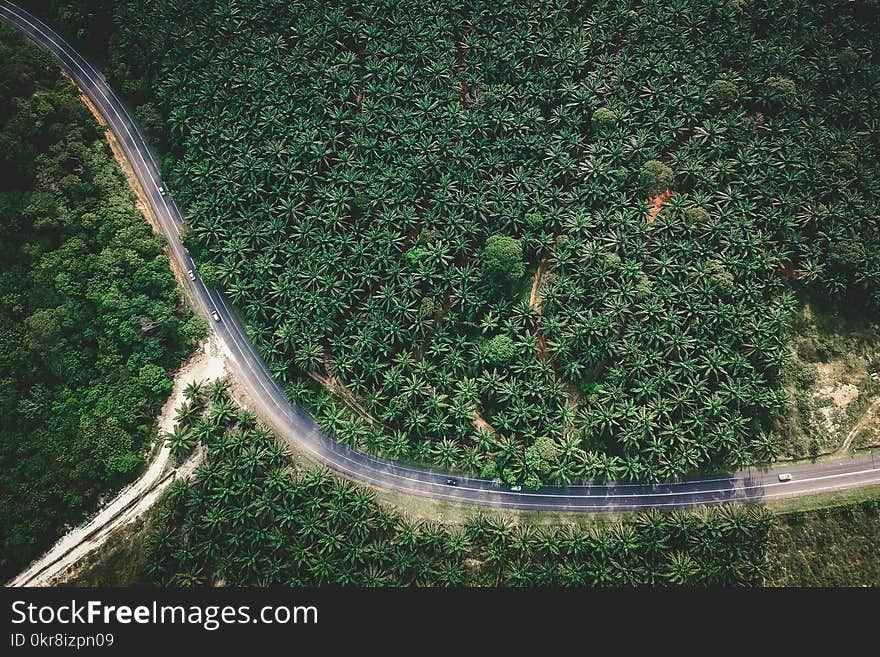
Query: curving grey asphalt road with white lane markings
[{"left": 6, "top": 0, "right": 880, "bottom": 512}]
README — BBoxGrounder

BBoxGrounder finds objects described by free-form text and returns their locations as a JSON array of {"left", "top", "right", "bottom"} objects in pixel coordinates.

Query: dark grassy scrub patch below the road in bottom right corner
[{"left": 767, "top": 498, "right": 880, "bottom": 587}]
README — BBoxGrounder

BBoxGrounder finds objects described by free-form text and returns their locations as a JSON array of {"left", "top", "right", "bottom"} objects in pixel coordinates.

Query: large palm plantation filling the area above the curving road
[{"left": 29, "top": 0, "right": 880, "bottom": 486}]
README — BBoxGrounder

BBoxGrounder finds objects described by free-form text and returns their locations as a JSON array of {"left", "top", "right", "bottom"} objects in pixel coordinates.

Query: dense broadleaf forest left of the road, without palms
[{"left": 0, "top": 24, "right": 199, "bottom": 578}]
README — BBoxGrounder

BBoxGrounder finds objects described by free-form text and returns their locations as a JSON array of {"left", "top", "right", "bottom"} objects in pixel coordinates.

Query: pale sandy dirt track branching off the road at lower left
[{"left": 8, "top": 338, "right": 226, "bottom": 586}]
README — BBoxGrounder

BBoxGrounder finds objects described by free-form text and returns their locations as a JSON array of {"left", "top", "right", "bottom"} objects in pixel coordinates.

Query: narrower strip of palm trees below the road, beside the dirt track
[{"left": 145, "top": 382, "right": 772, "bottom": 586}]
